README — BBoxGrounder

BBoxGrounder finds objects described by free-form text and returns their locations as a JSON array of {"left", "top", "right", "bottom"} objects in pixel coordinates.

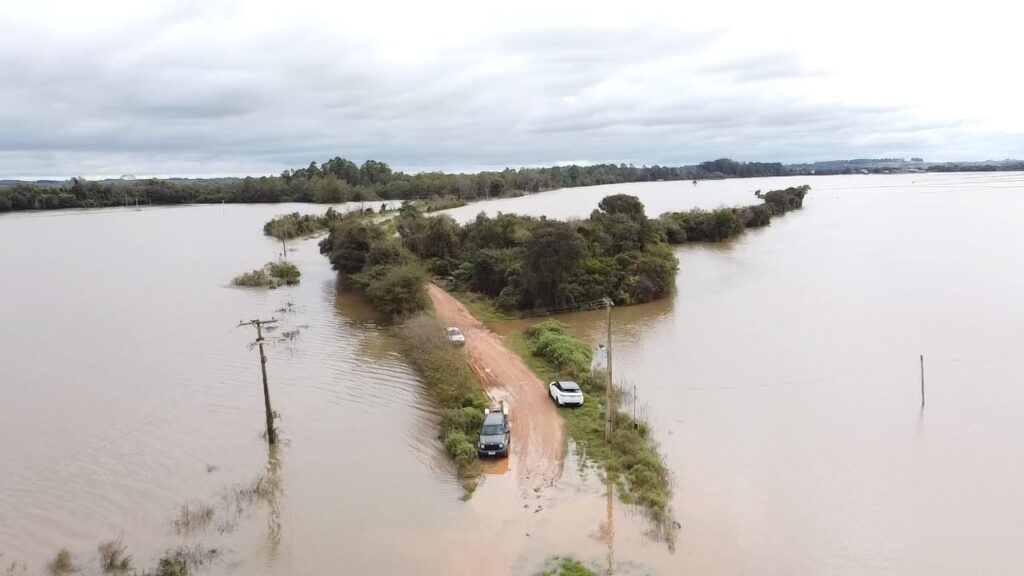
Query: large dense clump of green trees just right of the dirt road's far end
[{"left": 395, "top": 195, "right": 678, "bottom": 313}]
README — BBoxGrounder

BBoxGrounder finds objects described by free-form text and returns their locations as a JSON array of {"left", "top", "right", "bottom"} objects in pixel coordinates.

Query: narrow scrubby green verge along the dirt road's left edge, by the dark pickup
[{"left": 396, "top": 315, "right": 488, "bottom": 495}]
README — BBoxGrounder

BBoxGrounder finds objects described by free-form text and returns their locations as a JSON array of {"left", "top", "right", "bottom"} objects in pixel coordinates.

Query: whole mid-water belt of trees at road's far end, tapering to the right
[{"left": 321, "top": 186, "right": 809, "bottom": 316}]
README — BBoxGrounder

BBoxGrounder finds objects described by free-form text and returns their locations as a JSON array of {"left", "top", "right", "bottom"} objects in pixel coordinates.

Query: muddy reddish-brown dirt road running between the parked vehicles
[{"left": 427, "top": 284, "right": 565, "bottom": 489}]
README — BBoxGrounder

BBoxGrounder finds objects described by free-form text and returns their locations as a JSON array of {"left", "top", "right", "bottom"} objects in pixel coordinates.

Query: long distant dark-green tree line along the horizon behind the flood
[{"left": 0, "top": 158, "right": 811, "bottom": 212}]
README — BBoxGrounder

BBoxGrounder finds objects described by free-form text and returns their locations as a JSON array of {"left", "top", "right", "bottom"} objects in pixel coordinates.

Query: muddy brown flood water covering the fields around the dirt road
[{"left": 0, "top": 173, "right": 1024, "bottom": 575}]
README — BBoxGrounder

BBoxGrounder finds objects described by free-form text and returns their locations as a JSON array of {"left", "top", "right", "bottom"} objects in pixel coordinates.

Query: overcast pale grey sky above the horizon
[{"left": 0, "top": 0, "right": 1024, "bottom": 178}]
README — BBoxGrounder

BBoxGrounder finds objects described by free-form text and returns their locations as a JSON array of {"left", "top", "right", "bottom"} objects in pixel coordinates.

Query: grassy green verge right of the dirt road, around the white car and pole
[{"left": 516, "top": 320, "right": 674, "bottom": 528}]
